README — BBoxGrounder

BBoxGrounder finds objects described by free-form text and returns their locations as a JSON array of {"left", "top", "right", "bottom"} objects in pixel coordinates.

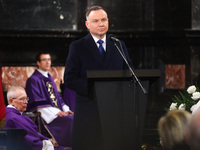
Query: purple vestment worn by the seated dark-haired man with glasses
[{"left": 26, "top": 70, "right": 73, "bottom": 147}]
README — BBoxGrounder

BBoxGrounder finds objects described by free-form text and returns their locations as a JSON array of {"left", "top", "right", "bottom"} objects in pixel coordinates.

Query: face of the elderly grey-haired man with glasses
[{"left": 9, "top": 89, "right": 28, "bottom": 112}]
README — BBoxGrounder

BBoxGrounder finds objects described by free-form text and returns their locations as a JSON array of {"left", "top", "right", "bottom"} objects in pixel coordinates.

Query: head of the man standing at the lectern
[{"left": 85, "top": 6, "right": 109, "bottom": 39}]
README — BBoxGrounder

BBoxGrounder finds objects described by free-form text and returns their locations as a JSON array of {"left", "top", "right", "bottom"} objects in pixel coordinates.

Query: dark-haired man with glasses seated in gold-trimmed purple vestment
[{"left": 25, "top": 52, "right": 74, "bottom": 147}]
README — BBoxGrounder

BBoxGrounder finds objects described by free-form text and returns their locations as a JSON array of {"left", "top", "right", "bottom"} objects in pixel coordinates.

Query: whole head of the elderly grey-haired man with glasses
[{"left": 7, "top": 86, "right": 29, "bottom": 112}]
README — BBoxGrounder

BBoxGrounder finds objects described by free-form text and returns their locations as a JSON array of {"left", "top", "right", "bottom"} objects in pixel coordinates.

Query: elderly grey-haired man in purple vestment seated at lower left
[{"left": 4, "top": 86, "right": 71, "bottom": 150}]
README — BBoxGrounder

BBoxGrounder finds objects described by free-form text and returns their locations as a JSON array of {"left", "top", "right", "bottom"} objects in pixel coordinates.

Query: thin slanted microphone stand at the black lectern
[{"left": 114, "top": 40, "right": 147, "bottom": 94}]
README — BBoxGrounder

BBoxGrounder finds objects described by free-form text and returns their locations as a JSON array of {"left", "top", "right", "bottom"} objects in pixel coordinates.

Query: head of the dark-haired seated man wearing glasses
[{"left": 36, "top": 52, "right": 51, "bottom": 71}]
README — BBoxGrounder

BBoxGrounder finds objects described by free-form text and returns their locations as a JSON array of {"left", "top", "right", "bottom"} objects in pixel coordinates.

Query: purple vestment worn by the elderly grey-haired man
[{"left": 4, "top": 107, "right": 68, "bottom": 150}]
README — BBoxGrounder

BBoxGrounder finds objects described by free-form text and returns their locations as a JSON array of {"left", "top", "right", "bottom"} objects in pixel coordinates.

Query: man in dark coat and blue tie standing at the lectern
[{"left": 64, "top": 6, "right": 131, "bottom": 150}]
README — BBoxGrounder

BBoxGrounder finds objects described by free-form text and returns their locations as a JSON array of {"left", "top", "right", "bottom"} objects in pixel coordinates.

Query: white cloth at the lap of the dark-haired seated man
[{"left": 38, "top": 107, "right": 61, "bottom": 124}]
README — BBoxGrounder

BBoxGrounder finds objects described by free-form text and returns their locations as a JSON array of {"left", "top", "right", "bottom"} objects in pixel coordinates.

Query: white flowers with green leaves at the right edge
[{"left": 169, "top": 85, "right": 200, "bottom": 112}]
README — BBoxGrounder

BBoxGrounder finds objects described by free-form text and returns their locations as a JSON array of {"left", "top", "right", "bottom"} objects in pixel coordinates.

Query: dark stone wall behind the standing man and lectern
[{"left": 0, "top": 0, "right": 200, "bottom": 148}]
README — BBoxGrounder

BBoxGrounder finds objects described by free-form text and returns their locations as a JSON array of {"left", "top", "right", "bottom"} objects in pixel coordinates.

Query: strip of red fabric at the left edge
[{"left": 0, "top": 70, "right": 6, "bottom": 121}]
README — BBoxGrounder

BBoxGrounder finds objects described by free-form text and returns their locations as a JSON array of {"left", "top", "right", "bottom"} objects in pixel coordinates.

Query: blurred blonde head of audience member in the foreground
[{"left": 158, "top": 109, "right": 191, "bottom": 150}]
